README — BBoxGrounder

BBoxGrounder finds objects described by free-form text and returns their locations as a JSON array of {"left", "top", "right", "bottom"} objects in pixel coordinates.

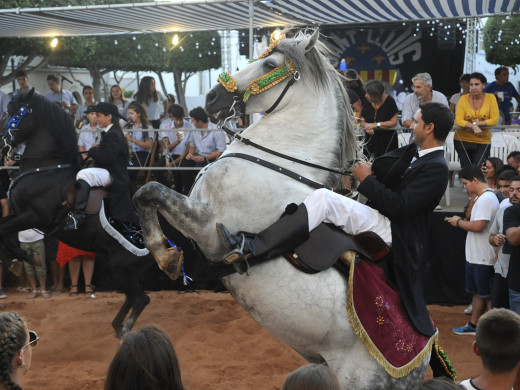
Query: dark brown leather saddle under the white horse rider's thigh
[{"left": 286, "top": 223, "right": 391, "bottom": 274}]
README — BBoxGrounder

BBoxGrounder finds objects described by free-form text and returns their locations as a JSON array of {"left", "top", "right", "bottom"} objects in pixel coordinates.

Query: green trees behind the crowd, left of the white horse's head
[{"left": 0, "top": 0, "right": 221, "bottom": 106}]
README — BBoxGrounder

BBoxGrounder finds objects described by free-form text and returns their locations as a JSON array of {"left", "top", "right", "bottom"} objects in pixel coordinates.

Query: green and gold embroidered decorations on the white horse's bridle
[{"left": 218, "top": 34, "right": 297, "bottom": 103}]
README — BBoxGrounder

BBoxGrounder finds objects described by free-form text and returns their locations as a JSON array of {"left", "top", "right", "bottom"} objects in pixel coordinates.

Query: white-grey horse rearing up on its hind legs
[{"left": 134, "top": 30, "right": 428, "bottom": 390}]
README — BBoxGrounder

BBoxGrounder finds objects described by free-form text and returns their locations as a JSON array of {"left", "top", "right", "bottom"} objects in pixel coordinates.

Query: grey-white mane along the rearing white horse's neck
[{"left": 274, "top": 28, "right": 360, "bottom": 169}]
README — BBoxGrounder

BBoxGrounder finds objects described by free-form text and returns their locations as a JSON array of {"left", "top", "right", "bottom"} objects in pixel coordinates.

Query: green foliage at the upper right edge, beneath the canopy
[{"left": 483, "top": 15, "right": 520, "bottom": 69}]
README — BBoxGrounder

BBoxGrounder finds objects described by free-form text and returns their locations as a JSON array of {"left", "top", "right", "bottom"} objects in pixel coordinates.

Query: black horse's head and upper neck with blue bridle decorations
[{"left": 3, "top": 88, "right": 77, "bottom": 162}]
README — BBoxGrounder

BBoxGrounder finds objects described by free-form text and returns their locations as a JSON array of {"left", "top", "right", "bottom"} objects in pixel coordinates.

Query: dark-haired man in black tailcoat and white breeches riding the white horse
[{"left": 219, "top": 103, "right": 454, "bottom": 336}]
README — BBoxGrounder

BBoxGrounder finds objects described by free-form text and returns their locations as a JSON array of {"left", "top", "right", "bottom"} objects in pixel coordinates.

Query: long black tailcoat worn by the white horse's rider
[{"left": 358, "top": 150, "right": 448, "bottom": 336}]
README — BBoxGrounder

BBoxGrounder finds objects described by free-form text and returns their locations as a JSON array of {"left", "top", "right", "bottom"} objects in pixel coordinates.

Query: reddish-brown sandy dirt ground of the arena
[{"left": 0, "top": 290, "right": 480, "bottom": 390}]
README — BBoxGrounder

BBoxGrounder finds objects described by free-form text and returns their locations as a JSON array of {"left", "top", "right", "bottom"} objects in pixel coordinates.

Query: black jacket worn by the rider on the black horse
[{"left": 88, "top": 125, "right": 139, "bottom": 223}]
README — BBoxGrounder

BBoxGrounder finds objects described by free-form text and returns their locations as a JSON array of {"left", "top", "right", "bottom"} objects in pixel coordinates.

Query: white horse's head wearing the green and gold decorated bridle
[{"left": 206, "top": 29, "right": 322, "bottom": 119}]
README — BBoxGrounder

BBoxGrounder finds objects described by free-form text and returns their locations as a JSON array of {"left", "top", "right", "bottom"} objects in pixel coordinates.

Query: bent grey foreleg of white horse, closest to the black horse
[{"left": 133, "top": 182, "right": 215, "bottom": 279}]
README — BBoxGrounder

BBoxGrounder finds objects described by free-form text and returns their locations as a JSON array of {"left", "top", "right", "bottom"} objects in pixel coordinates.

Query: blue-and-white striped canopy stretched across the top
[{"left": 0, "top": 0, "right": 520, "bottom": 37}]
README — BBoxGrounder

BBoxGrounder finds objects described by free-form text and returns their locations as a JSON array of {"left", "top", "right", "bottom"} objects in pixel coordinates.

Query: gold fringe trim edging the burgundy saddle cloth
[{"left": 347, "top": 262, "right": 439, "bottom": 378}]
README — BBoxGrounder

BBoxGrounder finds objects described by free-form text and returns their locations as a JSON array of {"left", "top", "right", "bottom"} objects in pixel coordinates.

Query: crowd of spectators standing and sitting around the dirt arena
[{"left": 0, "top": 67, "right": 520, "bottom": 390}]
